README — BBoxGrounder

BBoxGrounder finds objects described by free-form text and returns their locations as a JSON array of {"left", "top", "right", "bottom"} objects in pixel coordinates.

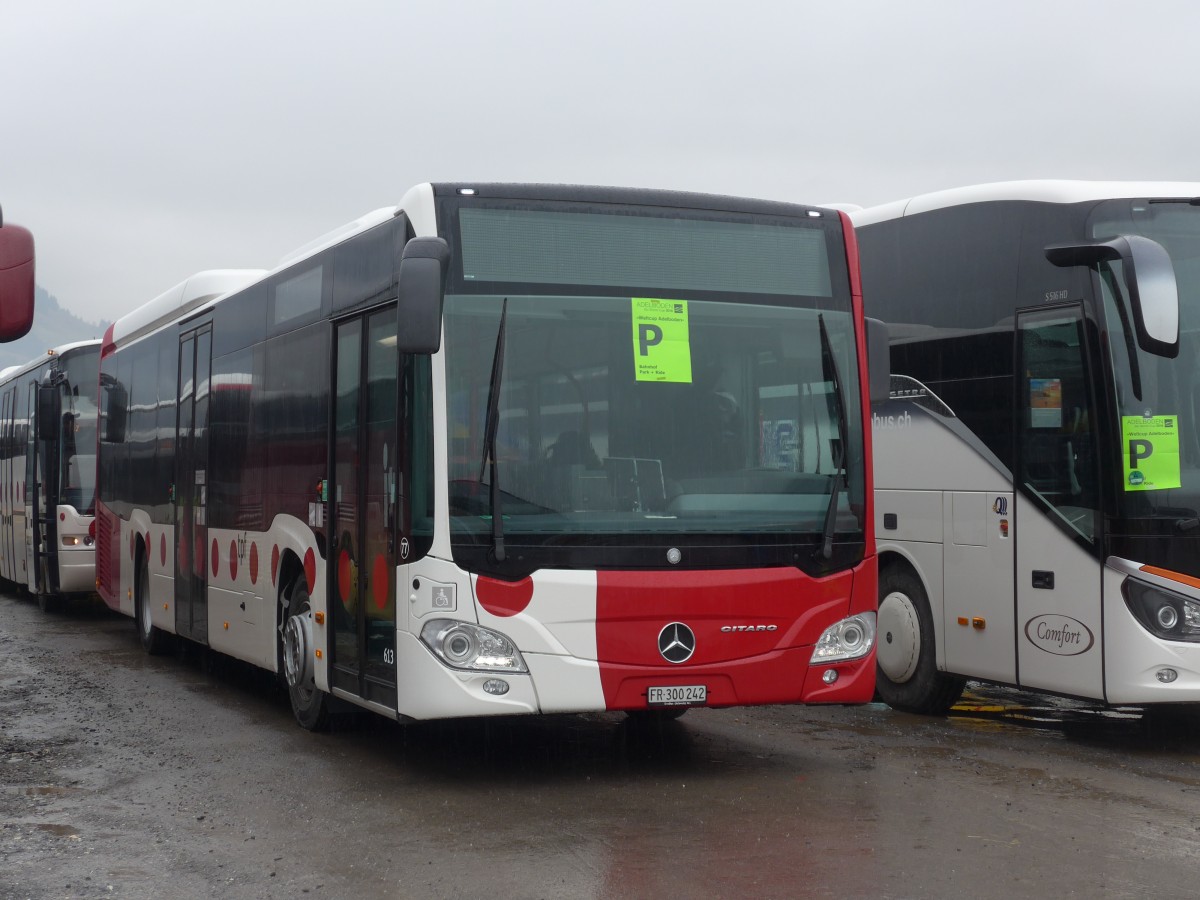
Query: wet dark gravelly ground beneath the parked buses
[{"left": 0, "top": 595, "right": 1200, "bottom": 899}]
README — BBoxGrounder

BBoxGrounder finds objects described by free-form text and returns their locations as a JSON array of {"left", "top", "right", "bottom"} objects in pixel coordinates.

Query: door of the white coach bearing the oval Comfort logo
[{"left": 1014, "top": 304, "right": 1104, "bottom": 697}]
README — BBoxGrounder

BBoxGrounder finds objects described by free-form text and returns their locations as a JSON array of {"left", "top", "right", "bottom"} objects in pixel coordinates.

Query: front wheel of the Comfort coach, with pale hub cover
[{"left": 875, "top": 566, "right": 966, "bottom": 715}]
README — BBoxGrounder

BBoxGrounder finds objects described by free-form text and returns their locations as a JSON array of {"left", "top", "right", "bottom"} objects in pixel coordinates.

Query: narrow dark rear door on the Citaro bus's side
[{"left": 173, "top": 325, "right": 212, "bottom": 643}]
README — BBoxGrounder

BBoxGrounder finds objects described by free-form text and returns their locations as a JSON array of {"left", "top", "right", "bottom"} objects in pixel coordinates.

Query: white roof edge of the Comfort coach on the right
[{"left": 850, "top": 180, "right": 1200, "bottom": 228}]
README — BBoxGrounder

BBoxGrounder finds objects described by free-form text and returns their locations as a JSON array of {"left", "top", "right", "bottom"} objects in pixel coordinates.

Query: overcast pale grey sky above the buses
[{"left": 0, "top": 0, "right": 1200, "bottom": 322}]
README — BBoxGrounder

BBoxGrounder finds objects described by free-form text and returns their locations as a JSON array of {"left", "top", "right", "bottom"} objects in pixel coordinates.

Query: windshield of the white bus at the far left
[{"left": 59, "top": 348, "right": 100, "bottom": 516}]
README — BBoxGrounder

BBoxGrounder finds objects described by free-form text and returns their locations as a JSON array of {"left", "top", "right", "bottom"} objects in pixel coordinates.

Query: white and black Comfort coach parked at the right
[{"left": 852, "top": 181, "right": 1200, "bottom": 713}]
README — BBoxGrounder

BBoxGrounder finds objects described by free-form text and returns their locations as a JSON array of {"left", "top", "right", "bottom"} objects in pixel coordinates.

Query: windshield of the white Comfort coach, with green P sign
[{"left": 1088, "top": 199, "right": 1200, "bottom": 522}]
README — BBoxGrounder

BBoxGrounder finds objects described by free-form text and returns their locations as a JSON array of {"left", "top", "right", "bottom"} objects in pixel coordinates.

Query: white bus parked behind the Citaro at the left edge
[{"left": 0, "top": 341, "right": 100, "bottom": 611}]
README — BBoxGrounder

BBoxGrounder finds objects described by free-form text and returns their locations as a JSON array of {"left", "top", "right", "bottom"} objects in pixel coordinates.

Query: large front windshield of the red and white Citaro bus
[{"left": 444, "top": 201, "right": 865, "bottom": 568}]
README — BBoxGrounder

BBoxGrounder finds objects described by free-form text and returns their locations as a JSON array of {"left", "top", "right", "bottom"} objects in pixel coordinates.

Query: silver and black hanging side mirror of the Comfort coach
[{"left": 1045, "top": 234, "right": 1180, "bottom": 359}]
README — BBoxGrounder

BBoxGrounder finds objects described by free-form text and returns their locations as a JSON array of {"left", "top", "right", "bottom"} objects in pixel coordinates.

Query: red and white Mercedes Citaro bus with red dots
[{"left": 97, "top": 185, "right": 886, "bottom": 728}]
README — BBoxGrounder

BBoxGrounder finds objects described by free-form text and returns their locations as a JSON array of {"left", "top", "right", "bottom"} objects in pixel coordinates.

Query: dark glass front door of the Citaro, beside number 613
[{"left": 328, "top": 307, "right": 397, "bottom": 709}]
